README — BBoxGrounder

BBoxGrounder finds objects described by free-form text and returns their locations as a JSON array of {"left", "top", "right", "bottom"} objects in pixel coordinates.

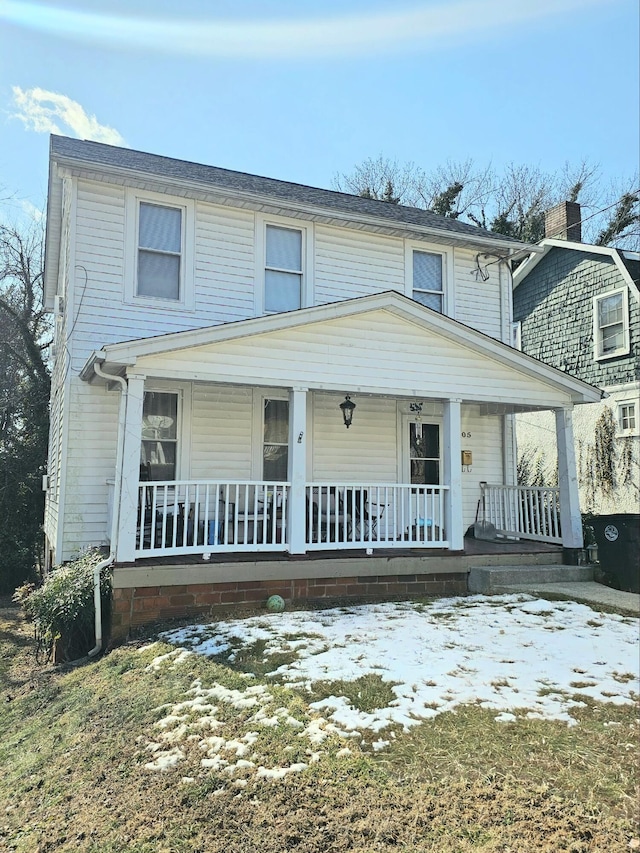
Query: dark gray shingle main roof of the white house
[{"left": 51, "top": 135, "right": 523, "bottom": 249}]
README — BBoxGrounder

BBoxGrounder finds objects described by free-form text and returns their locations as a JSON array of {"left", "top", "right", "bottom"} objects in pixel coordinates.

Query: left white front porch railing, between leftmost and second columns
[{"left": 135, "top": 480, "right": 289, "bottom": 557}]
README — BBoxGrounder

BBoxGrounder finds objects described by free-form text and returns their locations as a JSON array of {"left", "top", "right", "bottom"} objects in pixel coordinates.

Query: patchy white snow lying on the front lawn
[{"left": 139, "top": 595, "right": 640, "bottom": 787}]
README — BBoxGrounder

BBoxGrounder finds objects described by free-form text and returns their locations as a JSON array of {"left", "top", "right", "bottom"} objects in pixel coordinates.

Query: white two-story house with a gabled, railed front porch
[{"left": 45, "top": 136, "right": 599, "bottom": 632}]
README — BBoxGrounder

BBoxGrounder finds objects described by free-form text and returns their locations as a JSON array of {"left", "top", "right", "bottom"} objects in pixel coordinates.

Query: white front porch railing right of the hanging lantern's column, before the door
[{"left": 306, "top": 483, "right": 449, "bottom": 550}]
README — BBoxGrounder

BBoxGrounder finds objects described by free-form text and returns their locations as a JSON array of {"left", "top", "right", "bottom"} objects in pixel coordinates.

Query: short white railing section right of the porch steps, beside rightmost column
[{"left": 480, "top": 483, "right": 562, "bottom": 544}]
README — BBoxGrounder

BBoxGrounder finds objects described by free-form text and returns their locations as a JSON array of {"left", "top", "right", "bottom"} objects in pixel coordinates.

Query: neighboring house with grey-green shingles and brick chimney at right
[{"left": 513, "top": 203, "right": 640, "bottom": 515}]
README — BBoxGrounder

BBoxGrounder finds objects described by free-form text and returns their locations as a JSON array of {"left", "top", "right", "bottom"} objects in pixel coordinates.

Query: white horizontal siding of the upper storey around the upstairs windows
[{"left": 71, "top": 180, "right": 510, "bottom": 371}]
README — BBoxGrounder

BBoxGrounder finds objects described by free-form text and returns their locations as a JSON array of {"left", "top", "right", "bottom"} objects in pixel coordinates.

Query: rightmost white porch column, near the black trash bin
[{"left": 555, "top": 408, "right": 584, "bottom": 552}]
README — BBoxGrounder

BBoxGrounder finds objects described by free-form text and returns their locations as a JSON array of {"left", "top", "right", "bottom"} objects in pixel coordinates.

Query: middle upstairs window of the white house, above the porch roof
[{"left": 264, "top": 225, "right": 303, "bottom": 313}]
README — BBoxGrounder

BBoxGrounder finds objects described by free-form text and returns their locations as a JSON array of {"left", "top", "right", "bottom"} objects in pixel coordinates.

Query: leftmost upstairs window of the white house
[{"left": 136, "top": 202, "right": 182, "bottom": 301}]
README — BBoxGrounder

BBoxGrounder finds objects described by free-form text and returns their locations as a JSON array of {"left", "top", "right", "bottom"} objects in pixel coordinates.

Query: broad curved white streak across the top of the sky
[{"left": 0, "top": 0, "right": 608, "bottom": 59}]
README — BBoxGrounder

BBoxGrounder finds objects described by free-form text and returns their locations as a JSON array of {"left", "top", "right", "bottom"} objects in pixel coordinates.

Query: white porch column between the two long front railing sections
[{"left": 287, "top": 388, "right": 307, "bottom": 554}]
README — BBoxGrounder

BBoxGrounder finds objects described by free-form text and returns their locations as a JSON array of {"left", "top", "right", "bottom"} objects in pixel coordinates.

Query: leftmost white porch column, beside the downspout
[{"left": 114, "top": 374, "right": 145, "bottom": 563}]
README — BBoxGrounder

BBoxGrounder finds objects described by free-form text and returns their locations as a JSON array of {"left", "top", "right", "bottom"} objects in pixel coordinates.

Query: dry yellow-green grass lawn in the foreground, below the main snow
[{"left": 0, "top": 606, "right": 640, "bottom": 853}]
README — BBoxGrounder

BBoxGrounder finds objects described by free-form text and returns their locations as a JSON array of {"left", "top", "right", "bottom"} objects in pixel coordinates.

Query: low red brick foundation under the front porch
[{"left": 111, "top": 572, "right": 467, "bottom": 642}]
